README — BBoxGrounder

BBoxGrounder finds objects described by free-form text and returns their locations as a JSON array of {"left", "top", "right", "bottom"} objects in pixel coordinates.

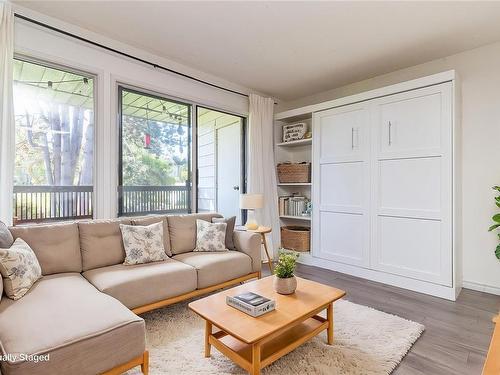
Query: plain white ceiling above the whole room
[{"left": 12, "top": 1, "right": 500, "bottom": 100}]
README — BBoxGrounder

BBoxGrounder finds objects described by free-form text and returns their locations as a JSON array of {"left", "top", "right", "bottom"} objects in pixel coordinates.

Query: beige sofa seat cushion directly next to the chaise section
[{"left": 83, "top": 259, "right": 196, "bottom": 309}]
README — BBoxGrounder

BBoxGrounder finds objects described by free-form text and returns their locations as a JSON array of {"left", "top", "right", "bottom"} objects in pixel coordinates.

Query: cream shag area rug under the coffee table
[{"left": 127, "top": 300, "right": 424, "bottom": 375}]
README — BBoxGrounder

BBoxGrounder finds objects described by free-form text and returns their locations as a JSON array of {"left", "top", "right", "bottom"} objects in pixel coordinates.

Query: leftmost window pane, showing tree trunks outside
[{"left": 14, "top": 59, "right": 94, "bottom": 224}]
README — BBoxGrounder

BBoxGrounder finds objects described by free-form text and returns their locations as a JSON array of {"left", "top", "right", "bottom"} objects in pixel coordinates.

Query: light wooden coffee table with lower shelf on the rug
[{"left": 189, "top": 276, "right": 345, "bottom": 375}]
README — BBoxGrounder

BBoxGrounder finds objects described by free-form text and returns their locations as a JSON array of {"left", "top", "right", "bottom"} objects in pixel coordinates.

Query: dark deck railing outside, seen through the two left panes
[{"left": 14, "top": 184, "right": 190, "bottom": 225}]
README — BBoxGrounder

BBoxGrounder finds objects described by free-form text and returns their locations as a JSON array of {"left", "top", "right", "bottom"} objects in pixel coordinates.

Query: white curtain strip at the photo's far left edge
[{"left": 0, "top": 2, "right": 15, "bottom": 224}]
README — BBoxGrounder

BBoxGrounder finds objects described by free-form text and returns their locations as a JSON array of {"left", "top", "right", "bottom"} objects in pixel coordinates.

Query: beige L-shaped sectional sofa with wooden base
[{"left": 0, "top": 214, "right": 261, "bottom": 375}]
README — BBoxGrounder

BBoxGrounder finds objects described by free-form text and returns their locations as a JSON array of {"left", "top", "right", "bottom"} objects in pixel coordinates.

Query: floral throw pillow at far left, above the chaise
[{"left": 0, "top": 238, "right": 42, "bottom": 300}]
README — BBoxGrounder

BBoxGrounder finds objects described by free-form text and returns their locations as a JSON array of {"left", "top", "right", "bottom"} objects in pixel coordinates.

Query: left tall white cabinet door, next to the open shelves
[{"left": 312, "top": 104, "right": 370, "bottom": 267}]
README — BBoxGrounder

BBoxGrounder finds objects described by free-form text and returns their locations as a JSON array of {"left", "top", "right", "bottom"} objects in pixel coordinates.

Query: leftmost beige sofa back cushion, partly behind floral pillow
[{"left": 10, "top": 223, "right": 82, "bottom": 275}]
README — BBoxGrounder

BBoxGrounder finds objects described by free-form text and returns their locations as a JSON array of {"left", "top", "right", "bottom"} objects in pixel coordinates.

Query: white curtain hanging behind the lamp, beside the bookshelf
[{"left": 247, "top": 94, "right": 280, "bottom": 257}]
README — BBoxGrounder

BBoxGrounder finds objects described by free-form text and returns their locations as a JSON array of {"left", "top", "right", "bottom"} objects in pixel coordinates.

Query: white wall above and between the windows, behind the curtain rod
[{"left": 15, "top": 6, "right": 256, "bottom": 218}]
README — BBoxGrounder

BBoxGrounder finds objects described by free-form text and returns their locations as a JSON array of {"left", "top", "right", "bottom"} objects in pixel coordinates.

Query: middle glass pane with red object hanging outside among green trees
[{"left": 118, "top": 87, "right": 191, "bottom": 216}]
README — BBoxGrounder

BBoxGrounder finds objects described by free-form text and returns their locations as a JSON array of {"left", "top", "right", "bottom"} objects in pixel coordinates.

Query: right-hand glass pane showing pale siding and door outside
[{"left": 197, "top": 107, "right": 245, "bottom": 224}]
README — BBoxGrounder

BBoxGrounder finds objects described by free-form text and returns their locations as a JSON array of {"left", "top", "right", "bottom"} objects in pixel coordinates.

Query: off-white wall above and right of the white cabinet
[{"left": 279, "top": 43, "right": 500, "bottom": 294}]
